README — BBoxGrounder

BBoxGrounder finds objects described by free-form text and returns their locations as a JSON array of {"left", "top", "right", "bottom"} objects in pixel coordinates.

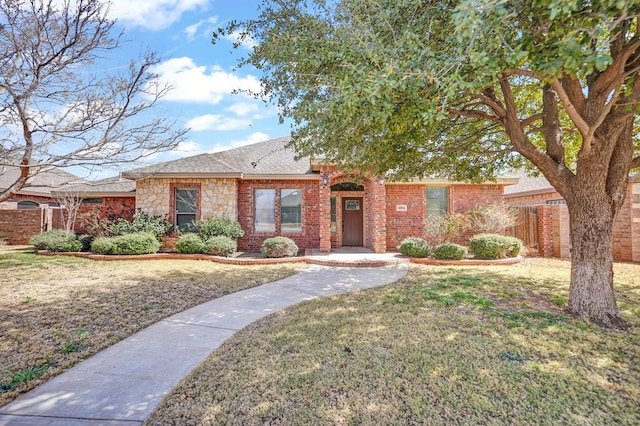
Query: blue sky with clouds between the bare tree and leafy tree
[{"left": 90, "top": 0, "right": 290, "bottom": 177}]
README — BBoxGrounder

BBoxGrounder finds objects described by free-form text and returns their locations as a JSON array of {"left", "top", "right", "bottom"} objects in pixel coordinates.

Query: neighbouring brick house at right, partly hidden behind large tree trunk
[{"left": 504, "top": 173, "right": 640, "bottom": 262}]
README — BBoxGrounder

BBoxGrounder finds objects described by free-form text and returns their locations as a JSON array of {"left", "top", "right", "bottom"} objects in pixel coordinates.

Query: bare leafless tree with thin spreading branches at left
[{"left": 0, "top": 0, "right": 186, "bottom": 201}]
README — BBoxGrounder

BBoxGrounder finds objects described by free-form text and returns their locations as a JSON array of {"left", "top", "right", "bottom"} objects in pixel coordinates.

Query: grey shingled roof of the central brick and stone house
[{"left": 123, "top": 137, "right": 313, "bottom": 179}]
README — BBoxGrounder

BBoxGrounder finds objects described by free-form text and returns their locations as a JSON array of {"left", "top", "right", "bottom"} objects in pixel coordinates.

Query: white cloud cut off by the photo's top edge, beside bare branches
[{"left": 109, "top": 0, "right": 211, "bottom": 30}]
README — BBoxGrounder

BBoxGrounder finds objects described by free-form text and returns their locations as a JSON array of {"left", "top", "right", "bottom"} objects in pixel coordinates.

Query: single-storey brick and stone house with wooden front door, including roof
[{"left": 123, "top": 138, "right": 517, "bottom": 252}]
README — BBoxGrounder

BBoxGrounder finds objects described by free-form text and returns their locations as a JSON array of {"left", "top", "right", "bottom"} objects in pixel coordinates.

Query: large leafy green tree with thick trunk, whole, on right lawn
[{"left": 219, "top": 0, "right": 640, "bottom": 326}]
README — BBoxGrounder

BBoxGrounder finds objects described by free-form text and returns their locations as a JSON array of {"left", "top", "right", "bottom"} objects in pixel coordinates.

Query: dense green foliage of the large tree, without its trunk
[{"left": 226, "top": 0, "right": 639, "bottom": 181}]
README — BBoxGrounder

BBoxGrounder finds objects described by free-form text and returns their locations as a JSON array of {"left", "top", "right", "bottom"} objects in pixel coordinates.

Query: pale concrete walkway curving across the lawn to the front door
[{"left": 0, "top": 265, "right": 407, "bottom": 426}]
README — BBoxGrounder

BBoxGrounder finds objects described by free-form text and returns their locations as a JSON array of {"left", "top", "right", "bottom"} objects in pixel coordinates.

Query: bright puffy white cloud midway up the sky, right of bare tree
[{"left": 152, "top": 57, "right": 261, "bottom": 105}]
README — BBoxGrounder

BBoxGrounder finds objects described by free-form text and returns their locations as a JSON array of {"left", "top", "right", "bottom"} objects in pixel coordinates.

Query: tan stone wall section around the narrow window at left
[{"left": 136, "top": 178, "right": 238, "bottom": 219}]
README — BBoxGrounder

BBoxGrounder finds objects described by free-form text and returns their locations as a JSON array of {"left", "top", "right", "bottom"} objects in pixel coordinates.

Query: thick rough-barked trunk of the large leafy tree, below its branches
[{"left": 567, "top": 179, "right": 626, "bottom": 328}]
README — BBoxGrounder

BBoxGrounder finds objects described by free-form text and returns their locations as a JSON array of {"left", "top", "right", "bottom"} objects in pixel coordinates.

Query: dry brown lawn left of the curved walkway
[{"left": 0, "top": 246, "right": 304, "bottom": 405}]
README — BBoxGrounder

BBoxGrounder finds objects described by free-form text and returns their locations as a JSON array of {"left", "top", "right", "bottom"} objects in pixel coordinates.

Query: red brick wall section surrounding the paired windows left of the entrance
[{"left": 238, "top": 180, "right": 320, "bottom": 253}]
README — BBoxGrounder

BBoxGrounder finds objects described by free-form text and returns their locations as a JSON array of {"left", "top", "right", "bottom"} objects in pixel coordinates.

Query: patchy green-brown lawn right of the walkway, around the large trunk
[{"left": 147, "top": 259, "right": 640, "bottom": 425}]
